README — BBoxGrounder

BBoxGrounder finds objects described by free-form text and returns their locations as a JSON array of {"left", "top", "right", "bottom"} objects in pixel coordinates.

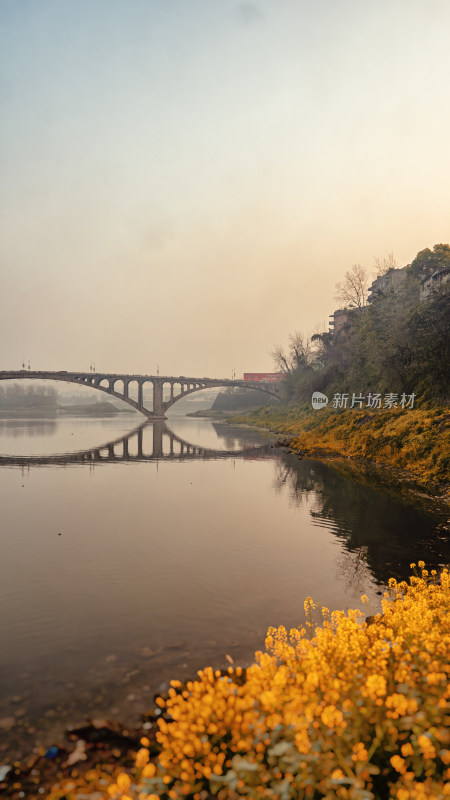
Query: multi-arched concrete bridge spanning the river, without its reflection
[{"left": 0, "top": 369, "right": 282, "bottom": 419}]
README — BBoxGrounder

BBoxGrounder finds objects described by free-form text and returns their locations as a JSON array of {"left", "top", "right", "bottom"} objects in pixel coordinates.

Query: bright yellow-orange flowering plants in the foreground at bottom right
[{"left": 59, "top": 562, "right": 450, "bottom": 800}]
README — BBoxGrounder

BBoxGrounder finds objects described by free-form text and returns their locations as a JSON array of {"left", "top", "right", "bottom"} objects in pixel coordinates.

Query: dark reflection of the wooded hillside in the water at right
[{"left": 273, "top": 456, "right": 450, "bottom": 591}]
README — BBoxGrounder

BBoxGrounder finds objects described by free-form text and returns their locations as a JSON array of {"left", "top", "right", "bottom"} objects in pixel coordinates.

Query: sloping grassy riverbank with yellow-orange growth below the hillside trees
[{"left": 233, "top": 406, "right": 450, "bottom": 502}]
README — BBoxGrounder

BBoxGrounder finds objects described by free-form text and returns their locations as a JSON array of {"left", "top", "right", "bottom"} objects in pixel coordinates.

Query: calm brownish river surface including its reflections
[{"left": 0, "top": 415, "right": 450, "bottom": 761}]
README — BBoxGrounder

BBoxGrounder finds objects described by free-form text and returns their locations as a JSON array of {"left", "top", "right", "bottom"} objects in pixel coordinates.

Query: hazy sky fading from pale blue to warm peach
[{"left": 0, "top": 0, "right": 450, "bottom": 377}]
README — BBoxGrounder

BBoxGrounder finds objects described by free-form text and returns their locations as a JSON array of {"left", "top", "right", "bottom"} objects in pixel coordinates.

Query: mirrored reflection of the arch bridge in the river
[{"left": 0, "top": 420, "right": 275, "bottom": 467}]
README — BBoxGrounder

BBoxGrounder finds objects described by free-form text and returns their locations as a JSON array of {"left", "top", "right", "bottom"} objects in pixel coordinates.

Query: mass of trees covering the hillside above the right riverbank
[{"left": 272, "top": 244, "right": 450, "bottom": 402}]
